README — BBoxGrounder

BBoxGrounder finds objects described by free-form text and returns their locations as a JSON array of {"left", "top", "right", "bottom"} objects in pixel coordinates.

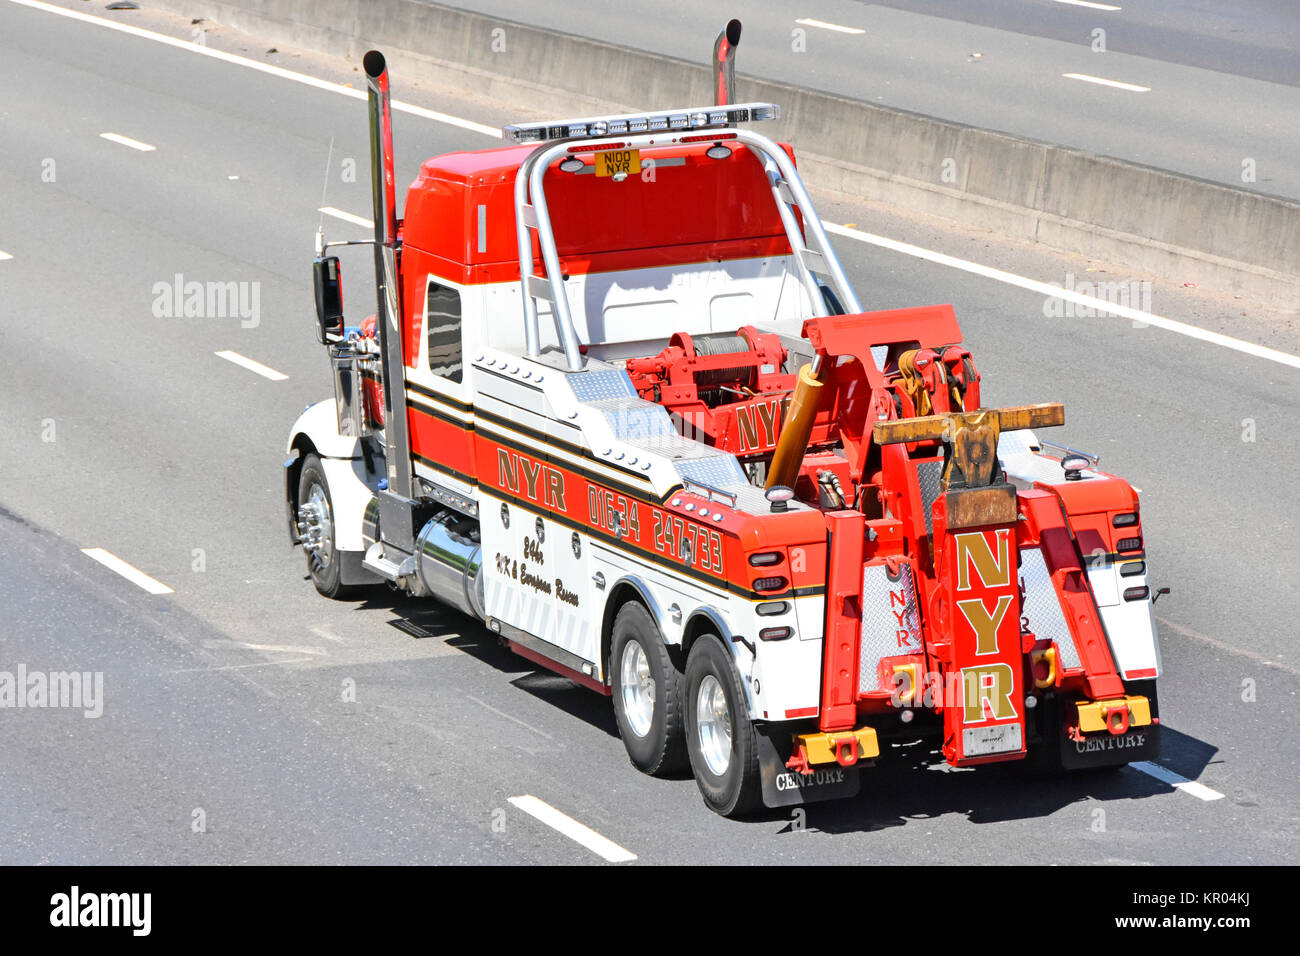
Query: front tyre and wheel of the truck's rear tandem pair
[{"left": 610, "top": 601, "right": 686, "bottom": 777}]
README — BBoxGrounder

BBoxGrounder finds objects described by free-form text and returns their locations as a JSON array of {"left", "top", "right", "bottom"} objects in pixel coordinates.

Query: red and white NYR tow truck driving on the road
[{"left": 285, "top": 21, "right": 1160, "bottom": 816}]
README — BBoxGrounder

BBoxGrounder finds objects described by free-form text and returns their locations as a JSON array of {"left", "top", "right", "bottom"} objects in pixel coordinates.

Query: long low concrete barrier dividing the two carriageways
[{"left": 151, "top": 0, "right": 1300, "bottom": 311}]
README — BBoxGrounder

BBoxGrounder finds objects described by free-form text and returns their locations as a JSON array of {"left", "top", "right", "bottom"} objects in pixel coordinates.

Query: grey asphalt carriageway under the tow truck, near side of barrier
[{"left": 0, "top": 3, "right": 1300, "bottom": 865}]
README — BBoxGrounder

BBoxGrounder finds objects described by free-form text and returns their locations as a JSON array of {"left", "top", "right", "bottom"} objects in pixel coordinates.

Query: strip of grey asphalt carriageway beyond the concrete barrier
[{"left": 438, "top": 0, "right": 1300, "bottom": 199}]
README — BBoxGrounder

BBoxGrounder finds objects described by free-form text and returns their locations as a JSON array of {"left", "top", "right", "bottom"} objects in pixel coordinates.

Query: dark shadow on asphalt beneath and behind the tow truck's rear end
[{"left": 772, "top": 723, "right": 1218, "bottom": 832}]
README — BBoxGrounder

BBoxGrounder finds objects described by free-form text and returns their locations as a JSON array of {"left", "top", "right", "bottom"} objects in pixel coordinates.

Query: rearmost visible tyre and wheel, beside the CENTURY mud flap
[{"left": 685, "top": 635, "right": 762, "bottom": 817}]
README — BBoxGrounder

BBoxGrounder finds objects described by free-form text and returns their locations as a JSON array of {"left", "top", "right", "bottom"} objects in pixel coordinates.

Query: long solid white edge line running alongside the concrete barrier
[{"left": 17, "top": 0, "right": 1300, "bottom": 368}]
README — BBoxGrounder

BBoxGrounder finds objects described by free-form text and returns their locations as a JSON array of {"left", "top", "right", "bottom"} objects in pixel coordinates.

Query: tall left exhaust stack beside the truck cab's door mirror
[{"left": 361, "top": 49, "right": 413, "bottom": 502}]
